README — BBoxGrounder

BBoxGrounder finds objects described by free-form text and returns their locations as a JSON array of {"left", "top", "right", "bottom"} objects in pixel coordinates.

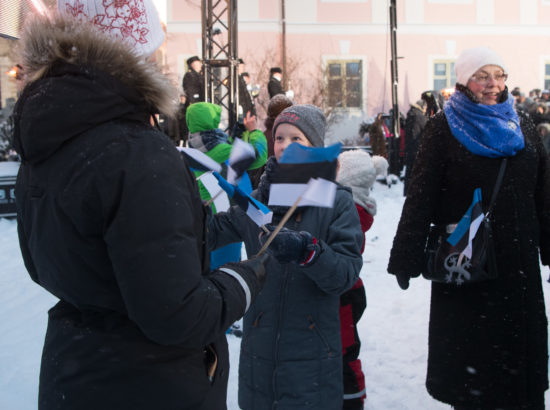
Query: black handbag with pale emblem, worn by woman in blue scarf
[{"left": 422, "top": 158, "right": 506, "bottom": 286}]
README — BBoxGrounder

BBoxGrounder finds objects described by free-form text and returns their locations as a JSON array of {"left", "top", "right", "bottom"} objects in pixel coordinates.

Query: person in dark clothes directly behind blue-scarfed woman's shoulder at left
[{"left": 403, "top": 100, "right": 428, "bottom": 196}]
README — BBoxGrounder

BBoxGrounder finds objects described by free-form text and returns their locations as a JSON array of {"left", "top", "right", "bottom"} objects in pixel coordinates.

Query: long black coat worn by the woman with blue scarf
[{"left": 388, "top": 108, "right": 550, "bottom": 408}]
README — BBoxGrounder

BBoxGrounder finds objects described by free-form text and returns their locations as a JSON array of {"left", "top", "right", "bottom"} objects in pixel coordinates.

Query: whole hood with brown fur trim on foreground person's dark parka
[{"left": 14, "top": 15, "right": 177, "bottom": 163}]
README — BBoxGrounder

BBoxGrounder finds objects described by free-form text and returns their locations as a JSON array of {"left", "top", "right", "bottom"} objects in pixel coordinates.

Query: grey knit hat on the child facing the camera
[{"left": 273, "top": 104, "right": 326, "bottom": 147}]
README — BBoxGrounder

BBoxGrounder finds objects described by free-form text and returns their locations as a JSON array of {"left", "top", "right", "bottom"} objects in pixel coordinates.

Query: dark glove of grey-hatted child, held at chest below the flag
[{"left": 260, "top": 225, "right": 320, "bottom": 265}]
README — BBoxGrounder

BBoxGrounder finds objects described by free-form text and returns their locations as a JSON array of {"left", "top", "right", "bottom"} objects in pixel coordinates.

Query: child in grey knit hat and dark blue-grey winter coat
[{"left": 208, "top": 105, "right": 363, "bottom": 410}]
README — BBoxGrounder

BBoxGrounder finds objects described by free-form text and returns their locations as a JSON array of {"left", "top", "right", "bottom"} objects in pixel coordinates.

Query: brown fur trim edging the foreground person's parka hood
[{"left": 18, "top": 13, "right": 179, "bottom": 116}]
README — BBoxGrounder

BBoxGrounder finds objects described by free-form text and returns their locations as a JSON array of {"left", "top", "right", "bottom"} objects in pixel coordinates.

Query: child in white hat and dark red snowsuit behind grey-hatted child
[{"left": 336, "top": 150, "right": 376, "bottom": 410}]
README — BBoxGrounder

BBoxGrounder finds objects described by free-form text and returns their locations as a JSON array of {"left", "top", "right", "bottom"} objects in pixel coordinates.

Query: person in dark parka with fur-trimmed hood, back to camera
[{"left": 14, "top": 7, "right": 265, "bottom": 410}]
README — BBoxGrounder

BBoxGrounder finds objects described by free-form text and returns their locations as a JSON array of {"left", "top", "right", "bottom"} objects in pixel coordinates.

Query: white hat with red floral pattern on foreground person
[{"left": 57, "top": 0, "right": 164, "bottom": 57}]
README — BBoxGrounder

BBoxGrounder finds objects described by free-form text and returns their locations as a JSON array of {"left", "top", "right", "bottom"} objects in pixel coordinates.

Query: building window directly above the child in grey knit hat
[{"left": 327, "top": 60, "right": 363, "bottom": 108}]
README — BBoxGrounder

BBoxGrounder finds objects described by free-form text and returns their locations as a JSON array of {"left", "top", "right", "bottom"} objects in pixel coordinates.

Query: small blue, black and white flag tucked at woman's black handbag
[{"left": 447, "top": 188, "right": 485, "bottom": 259}]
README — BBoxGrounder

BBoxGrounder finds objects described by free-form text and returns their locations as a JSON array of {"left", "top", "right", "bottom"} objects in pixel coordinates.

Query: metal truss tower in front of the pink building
[{"left": 202, "top": 0, "right": 239, "bottom": 129}]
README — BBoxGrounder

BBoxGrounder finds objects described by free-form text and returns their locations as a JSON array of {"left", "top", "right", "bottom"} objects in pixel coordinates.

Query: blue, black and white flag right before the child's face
[{"left": 268, "top": 143, "right": 341, "bottom": 208}]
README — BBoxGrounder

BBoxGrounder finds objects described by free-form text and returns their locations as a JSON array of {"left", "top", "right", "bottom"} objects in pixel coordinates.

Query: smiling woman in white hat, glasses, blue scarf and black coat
[{"left": 388, "top": 47, "right": 550, "bottom": 410}]
